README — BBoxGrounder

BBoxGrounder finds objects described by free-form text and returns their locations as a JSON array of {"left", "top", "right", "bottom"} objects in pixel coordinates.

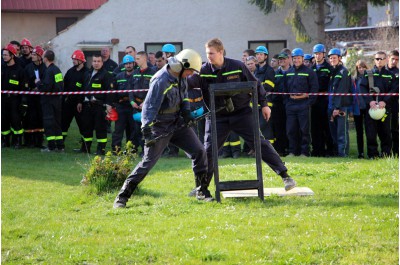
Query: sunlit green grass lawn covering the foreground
[{"left": 1, "top": 122, "right": 399, "bottom": 265}]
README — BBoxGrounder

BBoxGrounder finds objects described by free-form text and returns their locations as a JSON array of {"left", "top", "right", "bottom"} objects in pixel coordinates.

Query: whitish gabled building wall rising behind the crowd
[{"left": 52, "top": 0, "right": 315, "bottom": 72}]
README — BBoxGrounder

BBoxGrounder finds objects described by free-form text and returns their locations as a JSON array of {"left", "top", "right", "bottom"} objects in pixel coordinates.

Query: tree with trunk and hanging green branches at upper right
[{"left": 248, "top": 0, "right": 390, "bottom": 43}]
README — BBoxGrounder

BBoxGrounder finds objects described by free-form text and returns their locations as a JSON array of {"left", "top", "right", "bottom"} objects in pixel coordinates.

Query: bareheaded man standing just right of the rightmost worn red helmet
[{"left": 77, "top": 55, "right": 112, "bottom": 155}]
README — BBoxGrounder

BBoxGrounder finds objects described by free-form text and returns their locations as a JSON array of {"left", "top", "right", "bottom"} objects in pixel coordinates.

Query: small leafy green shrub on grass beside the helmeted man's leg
[{"left": 81, "top": 141, "right": 137, "bottom": 194}]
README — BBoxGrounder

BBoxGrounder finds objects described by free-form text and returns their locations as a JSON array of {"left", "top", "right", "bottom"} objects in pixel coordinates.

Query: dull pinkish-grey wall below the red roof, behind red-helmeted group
[{"left": 1, "top": 12, "right": 87, "bottom": 47}]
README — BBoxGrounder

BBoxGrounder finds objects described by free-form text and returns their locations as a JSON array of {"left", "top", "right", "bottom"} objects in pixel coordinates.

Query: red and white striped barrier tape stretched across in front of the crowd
[{"left": 1, "top": 89, "right": 399, "bottom": 96}]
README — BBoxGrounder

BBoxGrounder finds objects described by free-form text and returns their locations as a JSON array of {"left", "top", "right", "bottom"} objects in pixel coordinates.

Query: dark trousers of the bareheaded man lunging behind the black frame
[{"left": 204, "top": 107, "right": 287, "bottom": 186}]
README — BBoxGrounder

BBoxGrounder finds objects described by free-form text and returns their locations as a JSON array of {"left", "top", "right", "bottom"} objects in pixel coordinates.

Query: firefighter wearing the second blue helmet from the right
[{"left": 311, "top": 44, "right": 334, "bottom": 157}]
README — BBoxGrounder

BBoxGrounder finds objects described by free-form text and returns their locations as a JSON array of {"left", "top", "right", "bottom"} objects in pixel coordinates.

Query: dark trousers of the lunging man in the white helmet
[{"left": 118, "top": 121, "right": 207, "bottom": 198}]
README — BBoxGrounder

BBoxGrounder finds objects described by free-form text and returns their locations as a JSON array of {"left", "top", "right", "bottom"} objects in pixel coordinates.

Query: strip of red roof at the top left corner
[{"left": 1, "top": 0, "right": 107, "bottom": 12}]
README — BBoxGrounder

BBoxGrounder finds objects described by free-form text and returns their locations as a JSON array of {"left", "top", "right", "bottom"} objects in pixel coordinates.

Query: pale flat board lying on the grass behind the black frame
[{"left": 221, "top": 187, "right": 314, "bottom": 198}]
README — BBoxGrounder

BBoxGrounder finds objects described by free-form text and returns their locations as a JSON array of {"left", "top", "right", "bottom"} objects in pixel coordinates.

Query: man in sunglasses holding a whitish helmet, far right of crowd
[{"left": 360, "top": 51, "right": 399, "bottom": 159}]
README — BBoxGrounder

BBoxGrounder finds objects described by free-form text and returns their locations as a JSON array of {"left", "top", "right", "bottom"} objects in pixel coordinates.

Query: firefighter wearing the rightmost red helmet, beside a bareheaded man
[{"left": 61, "top": 50, "right": 88, "bottom": 141}]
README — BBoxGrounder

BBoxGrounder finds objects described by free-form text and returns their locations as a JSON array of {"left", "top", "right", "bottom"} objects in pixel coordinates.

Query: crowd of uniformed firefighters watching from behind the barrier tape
[{"left": 1, "top": 39, "right": 399, "bottom": 158}]
